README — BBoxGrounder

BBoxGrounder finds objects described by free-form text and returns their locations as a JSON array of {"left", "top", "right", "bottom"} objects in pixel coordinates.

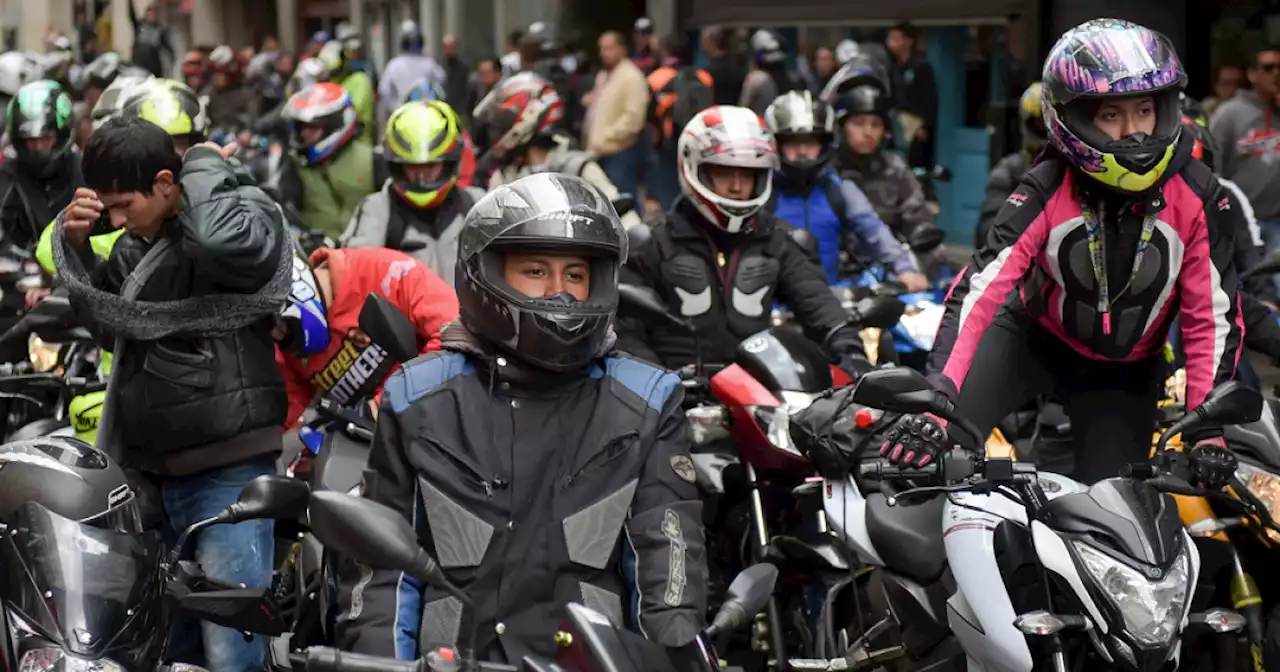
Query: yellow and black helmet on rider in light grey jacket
[{"left": 384, "top": 100, "right": 463, "bottom": 210}]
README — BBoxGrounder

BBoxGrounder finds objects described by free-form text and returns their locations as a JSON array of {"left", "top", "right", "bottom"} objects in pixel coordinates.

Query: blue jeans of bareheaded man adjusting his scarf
[{"left": 160, "top": 457, "right": 275, "bottom": 672}]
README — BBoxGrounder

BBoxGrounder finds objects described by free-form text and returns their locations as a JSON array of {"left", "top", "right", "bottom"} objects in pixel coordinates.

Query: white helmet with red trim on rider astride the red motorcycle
[{"left": 676, "top": 105, "right": 778, "bottom": 233}]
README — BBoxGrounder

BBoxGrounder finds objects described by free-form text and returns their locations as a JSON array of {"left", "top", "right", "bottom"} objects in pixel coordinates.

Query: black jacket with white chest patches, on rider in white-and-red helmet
[{"left": 618, "top": 198, "right": 865, "bottom": 369}]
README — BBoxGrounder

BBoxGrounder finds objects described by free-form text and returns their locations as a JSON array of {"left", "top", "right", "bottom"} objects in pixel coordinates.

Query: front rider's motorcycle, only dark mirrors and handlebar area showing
[{"left": 299, "top": 492, "right": 778, "bottom": 672}]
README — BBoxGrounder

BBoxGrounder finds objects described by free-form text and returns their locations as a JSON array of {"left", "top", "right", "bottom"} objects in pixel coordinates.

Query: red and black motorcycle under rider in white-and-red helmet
[{"left": 618, "top": 284, "right": 902, "bottom": 660}]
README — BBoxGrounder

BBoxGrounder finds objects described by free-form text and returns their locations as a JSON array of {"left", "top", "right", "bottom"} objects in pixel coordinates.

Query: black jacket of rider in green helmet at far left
[{"left": 0, "top": 151, "right": 84, "bottom": 250}]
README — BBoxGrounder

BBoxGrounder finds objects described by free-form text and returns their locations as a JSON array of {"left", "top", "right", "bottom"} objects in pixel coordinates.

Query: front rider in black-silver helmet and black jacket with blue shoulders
[{"left": 338, "top": 174, "right": 707, "bottom": 663}]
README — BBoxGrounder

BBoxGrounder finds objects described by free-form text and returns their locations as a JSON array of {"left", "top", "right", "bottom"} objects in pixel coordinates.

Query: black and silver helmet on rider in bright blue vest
[{"left": 764, "top": 91, "right": 836, "bottom": 188}]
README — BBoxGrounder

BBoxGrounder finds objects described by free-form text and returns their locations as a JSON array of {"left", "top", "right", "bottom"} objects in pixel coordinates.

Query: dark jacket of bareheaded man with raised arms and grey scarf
[{"left": 54, "top": 147, "right": 292, "bottom": 476}]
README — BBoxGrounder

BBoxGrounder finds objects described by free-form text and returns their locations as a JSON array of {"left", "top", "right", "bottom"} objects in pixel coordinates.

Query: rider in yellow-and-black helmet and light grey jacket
[{"left": 342, "top": 100, "right": 484, "bottom": 285}]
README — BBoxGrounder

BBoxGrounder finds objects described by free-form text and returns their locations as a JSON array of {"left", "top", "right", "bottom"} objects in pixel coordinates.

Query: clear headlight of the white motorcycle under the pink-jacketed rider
[{"left": 1073, "top": 541, "right": 1190, "bottom": 648}]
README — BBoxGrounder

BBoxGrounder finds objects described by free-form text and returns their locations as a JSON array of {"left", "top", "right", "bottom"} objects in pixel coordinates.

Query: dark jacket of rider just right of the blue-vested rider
[{"left": 836, "top": 147, "right": 933, "bottom": 241}]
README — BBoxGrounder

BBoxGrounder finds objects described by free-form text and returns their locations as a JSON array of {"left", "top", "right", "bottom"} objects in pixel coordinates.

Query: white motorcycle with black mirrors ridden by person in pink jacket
[{"left": 808, "top": 369, "right": 1261, "bottom": 672}]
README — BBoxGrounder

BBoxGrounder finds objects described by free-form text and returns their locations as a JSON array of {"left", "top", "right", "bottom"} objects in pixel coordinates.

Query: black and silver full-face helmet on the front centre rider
[{"left": 454, "top": 173, "right": 627, "bottom": 371}]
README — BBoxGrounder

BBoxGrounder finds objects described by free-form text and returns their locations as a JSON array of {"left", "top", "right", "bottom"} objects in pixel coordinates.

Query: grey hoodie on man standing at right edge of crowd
[{"left": 1208, "top": 91, "right": 1280, "bottom": 220}]
